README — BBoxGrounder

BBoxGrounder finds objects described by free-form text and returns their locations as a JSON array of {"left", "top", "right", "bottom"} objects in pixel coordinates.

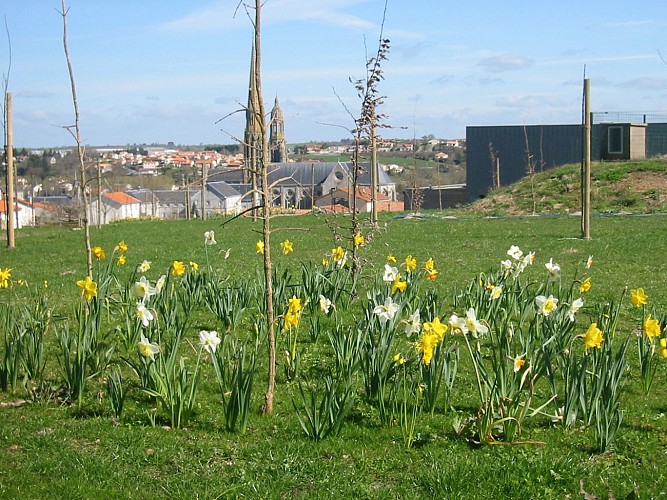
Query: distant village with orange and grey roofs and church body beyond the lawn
[{"left": 0, "top": 137, "right": 465, "bottom": 228}]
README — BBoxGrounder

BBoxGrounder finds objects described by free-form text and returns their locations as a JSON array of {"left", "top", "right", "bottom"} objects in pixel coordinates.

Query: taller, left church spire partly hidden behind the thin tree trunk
[{"left": 243, "top": 45, "right": 264, "bottom": 184}]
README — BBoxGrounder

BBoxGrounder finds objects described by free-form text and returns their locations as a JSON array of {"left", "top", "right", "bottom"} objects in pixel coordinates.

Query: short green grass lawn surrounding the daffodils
[{"left": 0, "top": 214, "right": 667, "bottom": 498}]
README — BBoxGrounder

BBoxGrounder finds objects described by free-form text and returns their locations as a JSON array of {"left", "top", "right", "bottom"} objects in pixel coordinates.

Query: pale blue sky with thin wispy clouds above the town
[{"left": 0, "top": 0, "right": 667, "bottom": 148}]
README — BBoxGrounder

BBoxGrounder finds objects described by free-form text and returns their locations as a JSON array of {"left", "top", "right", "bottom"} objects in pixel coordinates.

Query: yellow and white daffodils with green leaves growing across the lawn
[{"left": 0, "top": 230, "right": 667, "bottom": 456}]
